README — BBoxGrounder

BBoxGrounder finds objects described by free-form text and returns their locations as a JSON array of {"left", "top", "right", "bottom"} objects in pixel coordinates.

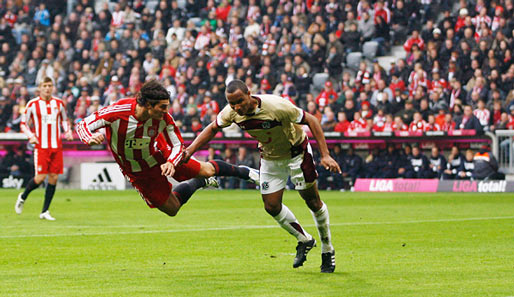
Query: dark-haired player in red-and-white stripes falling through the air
[{"left": 76, "top": 80, "right": 259, "bottom": 216}]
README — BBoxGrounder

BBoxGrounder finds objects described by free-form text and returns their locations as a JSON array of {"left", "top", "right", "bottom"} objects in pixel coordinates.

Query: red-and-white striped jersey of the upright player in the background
[{"left": 20, "top": 97, "right": 70, "bottom": 149}]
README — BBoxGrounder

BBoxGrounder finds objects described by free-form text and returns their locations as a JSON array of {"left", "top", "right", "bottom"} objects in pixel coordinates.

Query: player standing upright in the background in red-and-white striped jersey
[{"left": 14, "top": 77, "right": 73, "bottom": 221}]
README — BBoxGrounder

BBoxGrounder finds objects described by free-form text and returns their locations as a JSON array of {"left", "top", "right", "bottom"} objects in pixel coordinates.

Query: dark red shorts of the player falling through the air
[{"left": 126, "top": 159, "right": 201, "bottom": 208}]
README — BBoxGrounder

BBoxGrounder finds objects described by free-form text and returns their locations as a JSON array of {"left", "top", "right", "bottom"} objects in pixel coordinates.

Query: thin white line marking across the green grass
[{"left": 0, "top": 216, "right": 514, "bottom": 238}]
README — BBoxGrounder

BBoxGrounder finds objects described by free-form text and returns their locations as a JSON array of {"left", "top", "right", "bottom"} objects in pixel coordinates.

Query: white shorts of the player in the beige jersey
[{"left": 260, "top": 144, "right": 318, "bottom": 194}]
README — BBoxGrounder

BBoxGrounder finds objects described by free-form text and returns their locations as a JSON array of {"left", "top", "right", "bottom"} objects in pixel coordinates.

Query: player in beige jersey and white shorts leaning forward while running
[{"left": 184, "top": 80, "right": 341, "bottom": 273}]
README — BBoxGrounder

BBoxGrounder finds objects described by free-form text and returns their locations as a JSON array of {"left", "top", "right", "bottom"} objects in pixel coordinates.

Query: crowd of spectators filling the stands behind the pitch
[{"left": 0, "top": 0, "right": 514, "bottom": 136}]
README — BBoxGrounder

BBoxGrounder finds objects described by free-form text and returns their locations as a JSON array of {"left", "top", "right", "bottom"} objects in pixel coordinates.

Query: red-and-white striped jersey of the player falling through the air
[{"left": 76, "top": 98, "right": 184, "bottom": 173}]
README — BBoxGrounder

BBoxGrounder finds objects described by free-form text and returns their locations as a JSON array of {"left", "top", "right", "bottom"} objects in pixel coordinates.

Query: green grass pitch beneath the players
[{"left": 0, "top": 190, "right": 514, "bottom": 297}]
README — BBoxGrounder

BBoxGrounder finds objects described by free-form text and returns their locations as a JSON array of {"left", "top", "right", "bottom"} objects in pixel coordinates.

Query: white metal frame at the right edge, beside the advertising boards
[{"left": 492, "top": 130, "right": 514, "bottom": 174}]
